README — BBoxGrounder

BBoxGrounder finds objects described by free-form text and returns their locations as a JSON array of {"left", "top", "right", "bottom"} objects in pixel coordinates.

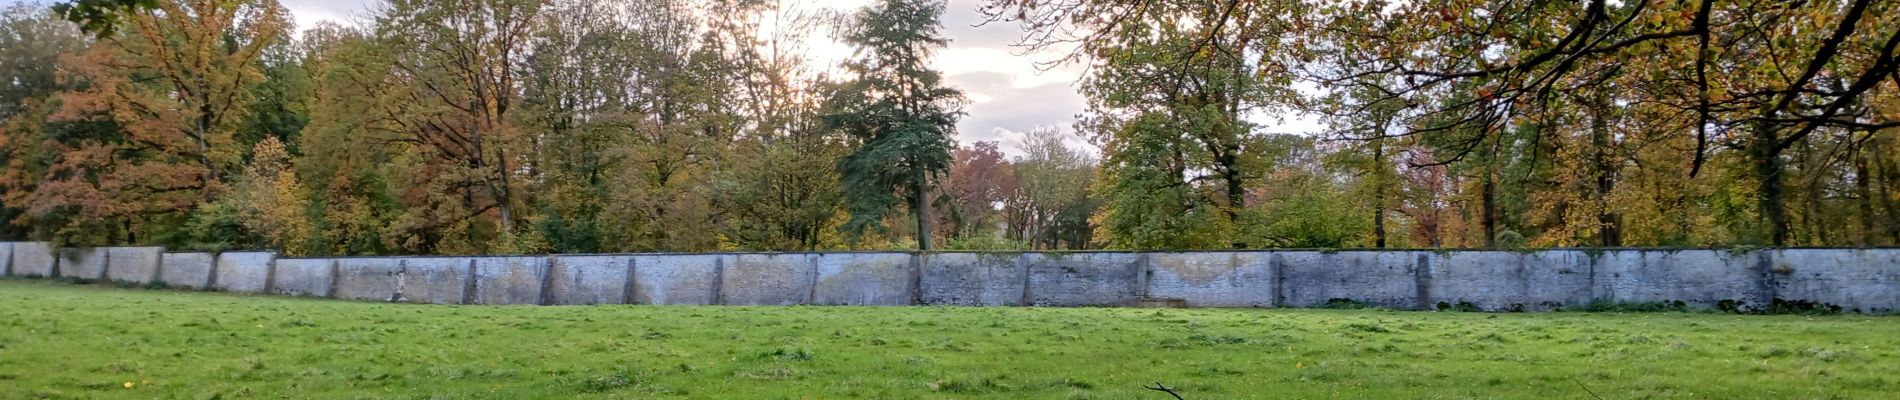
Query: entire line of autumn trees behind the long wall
[{"left": 0, "top": 0, "right": 1900, "bottom": 256}]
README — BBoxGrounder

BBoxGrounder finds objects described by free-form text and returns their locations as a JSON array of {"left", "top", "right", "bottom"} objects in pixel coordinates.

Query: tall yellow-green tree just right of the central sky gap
[{"left": 982, "top": 0, "right": 1307, "bottom": 246}]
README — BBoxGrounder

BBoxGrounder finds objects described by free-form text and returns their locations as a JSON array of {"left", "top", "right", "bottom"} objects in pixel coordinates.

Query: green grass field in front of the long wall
[{"left": 0, "top": 281, "right": 1900, "bottom": 400}]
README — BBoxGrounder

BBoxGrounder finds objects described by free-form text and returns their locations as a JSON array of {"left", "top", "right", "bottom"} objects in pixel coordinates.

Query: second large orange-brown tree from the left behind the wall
[{"left": 361, "top": 0, "right": 545, "bottom": 250}]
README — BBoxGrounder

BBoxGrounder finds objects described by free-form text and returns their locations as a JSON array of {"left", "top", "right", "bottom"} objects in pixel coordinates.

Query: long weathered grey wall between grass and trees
[{"left": 0, "top": 243, "right": 1900, "bottom": 313}]
